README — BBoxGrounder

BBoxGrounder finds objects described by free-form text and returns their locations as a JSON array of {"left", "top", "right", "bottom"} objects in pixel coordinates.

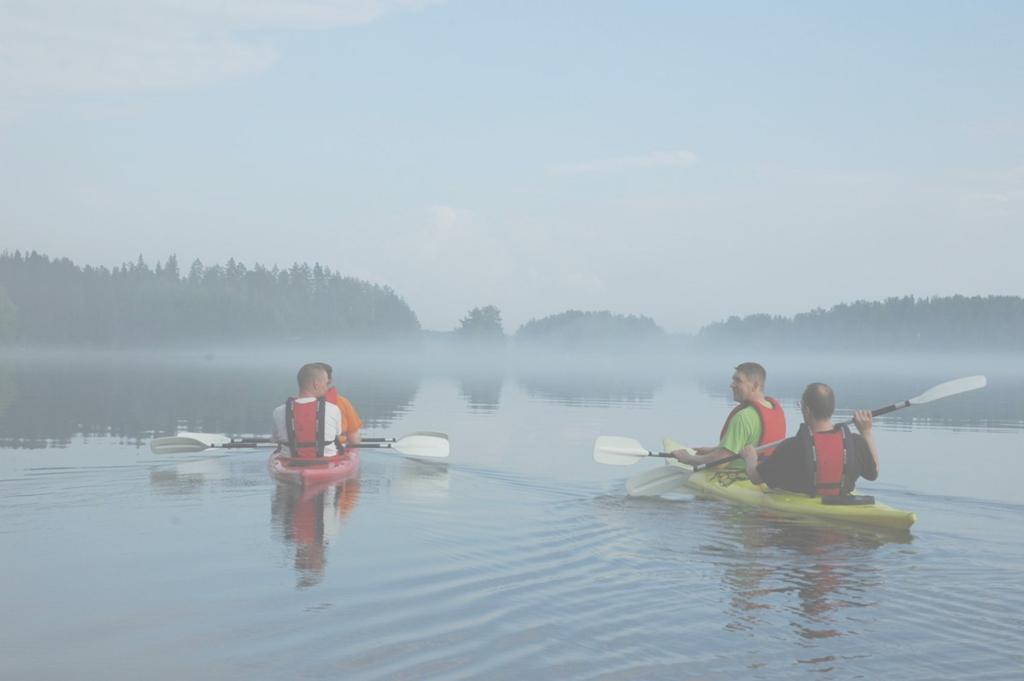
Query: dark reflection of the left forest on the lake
[{"left": 0, "top": 355, "right": 420, "bottom": 449}]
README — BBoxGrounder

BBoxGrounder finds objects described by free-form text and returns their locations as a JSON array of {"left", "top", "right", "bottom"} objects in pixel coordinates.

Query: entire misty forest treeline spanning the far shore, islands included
[{"left": 0, "top": 252, "right": 1024, "bottom": 352}]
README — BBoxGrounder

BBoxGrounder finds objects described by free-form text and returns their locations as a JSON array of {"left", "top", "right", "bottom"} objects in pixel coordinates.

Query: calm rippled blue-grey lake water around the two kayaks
[{"left": 0, "top": 353, "right": 1024, "bottom": 681}]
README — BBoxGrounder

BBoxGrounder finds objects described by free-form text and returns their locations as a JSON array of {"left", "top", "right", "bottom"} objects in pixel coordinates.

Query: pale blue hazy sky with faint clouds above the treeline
[{"left": 0, "top": 0, "right": 1024, "bottom": 332}]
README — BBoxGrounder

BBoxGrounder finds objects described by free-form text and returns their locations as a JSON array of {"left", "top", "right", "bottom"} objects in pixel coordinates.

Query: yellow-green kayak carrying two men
[{"left": 664, "top": 439, "right": 918, "bottom": 529}]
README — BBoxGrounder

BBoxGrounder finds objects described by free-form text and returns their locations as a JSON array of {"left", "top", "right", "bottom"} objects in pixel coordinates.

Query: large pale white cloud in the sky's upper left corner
[{"left": 0, "top": 0, "right": 430, "bottom": 96}]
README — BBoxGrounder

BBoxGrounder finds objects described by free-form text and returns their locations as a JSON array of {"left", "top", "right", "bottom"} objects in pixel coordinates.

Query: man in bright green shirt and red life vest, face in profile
[{"left": 672, "top": 361, "right": 785, "bottom": 469}]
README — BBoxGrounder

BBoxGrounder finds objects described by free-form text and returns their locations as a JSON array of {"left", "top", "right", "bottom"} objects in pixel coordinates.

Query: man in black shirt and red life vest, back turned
[{"left": 740, "top": 383, "right": 879, "bottom": 497}]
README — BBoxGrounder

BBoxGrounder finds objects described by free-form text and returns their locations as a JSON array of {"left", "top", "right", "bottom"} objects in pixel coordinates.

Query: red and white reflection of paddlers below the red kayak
[{"left": 270, "top": 478, "right": 359, "bottom": 587}]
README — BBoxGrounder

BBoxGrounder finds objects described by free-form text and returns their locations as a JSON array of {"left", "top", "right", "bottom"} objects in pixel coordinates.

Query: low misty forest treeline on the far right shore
[{"left": 695, "top": 296, "right": 1024, "bottom": 352}]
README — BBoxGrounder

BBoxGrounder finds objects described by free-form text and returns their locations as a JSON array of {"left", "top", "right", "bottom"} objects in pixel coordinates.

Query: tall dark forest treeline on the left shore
[{"left": 0, "top": 252, "right": 420, "bottom": 345}]
